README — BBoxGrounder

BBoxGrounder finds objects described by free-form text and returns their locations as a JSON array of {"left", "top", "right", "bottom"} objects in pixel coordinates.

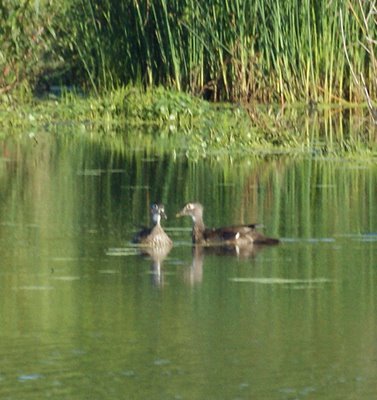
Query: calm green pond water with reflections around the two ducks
[{"left": 0, "top": 132, "right": 377, "bottom": 400}]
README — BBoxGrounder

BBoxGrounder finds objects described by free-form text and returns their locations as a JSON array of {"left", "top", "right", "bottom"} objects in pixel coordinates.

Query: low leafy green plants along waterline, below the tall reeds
[{"left": 0, "top": 87, "right": 377, "bottom": 159}]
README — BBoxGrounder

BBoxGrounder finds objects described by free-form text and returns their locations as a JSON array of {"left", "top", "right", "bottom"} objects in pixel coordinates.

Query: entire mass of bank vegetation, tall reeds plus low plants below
[{"left": 0, "top": 0, "right": 377, "bottom": 157}]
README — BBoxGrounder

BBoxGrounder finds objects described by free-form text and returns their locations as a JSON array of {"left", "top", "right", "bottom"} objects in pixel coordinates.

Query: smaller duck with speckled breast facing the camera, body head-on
[{"left": 133, "top": 204, "right": 173, "bottom": 249}]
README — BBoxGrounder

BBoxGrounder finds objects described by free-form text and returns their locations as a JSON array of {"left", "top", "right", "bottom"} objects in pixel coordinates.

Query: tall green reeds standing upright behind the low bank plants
[{"left": 0, "top": 0, "right": 377, "bottom": 103}]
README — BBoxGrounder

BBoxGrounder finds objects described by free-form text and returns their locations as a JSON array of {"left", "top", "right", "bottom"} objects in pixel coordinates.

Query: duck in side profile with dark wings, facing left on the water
[{"left": 177, "top": 203, "right": 279, "bottom": 246}]
